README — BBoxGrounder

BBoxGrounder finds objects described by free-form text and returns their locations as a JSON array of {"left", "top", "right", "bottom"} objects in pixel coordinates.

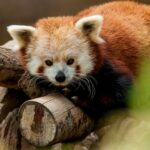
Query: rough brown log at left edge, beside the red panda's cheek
[{"left": 0, "top": 47, "right": 24, "bottom": 88}]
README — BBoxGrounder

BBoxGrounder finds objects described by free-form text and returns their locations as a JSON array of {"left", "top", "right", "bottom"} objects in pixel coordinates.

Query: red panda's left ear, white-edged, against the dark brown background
[{"left": 7, "top": 25, "right": 36, "bottom": 50}]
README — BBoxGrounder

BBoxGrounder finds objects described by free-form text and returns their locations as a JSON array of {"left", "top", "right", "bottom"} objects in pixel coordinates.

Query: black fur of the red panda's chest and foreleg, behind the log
[{"left": 66, "top": 61, "right": 132, "bottom": 118}]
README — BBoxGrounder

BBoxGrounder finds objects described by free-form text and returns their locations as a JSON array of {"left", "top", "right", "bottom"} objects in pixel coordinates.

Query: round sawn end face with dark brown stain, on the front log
[{"left": 20, "top": 102, "right": 56, "bottom": 146}]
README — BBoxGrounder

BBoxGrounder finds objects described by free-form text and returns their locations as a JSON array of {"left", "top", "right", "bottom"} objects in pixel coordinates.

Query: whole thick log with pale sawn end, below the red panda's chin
[{"left": 19, "top": 93, "right": 93, "bottom": 146}]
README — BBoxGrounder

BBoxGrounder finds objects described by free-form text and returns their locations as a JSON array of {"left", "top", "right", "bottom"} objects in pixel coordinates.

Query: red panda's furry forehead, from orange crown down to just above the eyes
[{"left": 32, "top": 17, "right": 89, "bottom": 60}]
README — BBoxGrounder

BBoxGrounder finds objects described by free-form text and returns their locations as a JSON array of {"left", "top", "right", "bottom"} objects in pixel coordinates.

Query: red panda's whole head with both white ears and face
[{"left": 8, "top": 15, "right": 103, "bottom": 86}]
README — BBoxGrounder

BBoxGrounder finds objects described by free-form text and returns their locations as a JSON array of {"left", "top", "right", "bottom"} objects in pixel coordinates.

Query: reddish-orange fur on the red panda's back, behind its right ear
[{"left": 78, "top": 1, "right": 150, "bottom": 75}]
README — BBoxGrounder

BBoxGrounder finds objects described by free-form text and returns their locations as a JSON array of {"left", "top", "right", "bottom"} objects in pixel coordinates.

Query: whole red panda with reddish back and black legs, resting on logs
[{"left": 8, "top": 1, "right": 150, "bottom": 117}]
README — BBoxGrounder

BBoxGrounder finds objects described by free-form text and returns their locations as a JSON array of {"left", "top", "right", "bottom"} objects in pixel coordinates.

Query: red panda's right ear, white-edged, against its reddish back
[{"left": 75, "top": 15, "right": 104, "bottom": 44}]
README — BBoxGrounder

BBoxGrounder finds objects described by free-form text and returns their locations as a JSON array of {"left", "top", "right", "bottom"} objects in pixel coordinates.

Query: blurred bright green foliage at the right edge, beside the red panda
[{"left": 129, "top": 59, "right": 150, "bottom": 115}]
